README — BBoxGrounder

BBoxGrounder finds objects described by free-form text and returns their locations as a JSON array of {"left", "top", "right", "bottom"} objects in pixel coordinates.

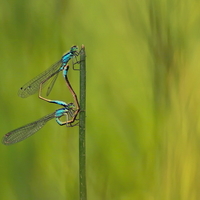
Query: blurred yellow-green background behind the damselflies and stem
[{"left": 0, "top": 0, "right": 200, "bottom": 200}]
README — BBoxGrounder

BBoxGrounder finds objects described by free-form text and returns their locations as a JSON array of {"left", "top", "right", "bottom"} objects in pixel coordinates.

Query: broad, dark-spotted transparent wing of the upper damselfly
[{"left": 18, "top": 60, "right": 62, "bottom": 98}]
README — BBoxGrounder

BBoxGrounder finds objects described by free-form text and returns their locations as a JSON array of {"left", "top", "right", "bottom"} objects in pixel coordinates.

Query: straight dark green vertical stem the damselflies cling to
[{"left": 79, "top": 45, "right": 87, "bottom": 200}]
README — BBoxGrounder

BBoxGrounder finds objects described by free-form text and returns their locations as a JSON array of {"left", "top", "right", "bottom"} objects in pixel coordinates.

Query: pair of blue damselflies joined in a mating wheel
[{"left": 2, "top": 46, "right": 80, "bottom": 145}]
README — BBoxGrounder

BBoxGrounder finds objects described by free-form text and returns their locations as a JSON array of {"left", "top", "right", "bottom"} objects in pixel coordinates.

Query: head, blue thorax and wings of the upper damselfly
[{"left": 18, "top": 46, "right": 78, "bottom": 98}]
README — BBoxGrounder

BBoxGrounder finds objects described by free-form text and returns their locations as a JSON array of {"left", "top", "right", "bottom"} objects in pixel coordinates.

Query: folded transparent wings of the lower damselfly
[{"left": 2, "top": 112, "right": 55, "bottom": 145}]
